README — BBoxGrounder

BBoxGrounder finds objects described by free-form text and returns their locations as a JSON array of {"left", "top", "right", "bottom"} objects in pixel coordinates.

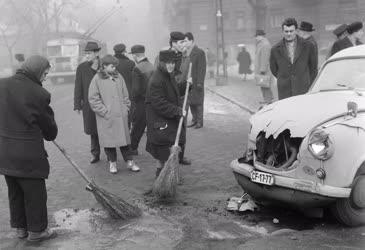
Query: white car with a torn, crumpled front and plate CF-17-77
[{"left": 231, "top": 45, "right": 365, "bottom": 226}]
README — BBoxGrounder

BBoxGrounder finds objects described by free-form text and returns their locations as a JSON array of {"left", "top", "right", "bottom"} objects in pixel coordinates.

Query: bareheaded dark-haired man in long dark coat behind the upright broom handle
[{"left": 185, "top": 32, "right": 207, "bottom": 129}]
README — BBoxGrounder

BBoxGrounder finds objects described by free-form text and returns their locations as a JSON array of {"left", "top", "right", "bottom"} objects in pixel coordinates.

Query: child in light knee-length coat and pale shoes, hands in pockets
[{"left": 89, "top": 55, "right": 140, "bottom": 174}]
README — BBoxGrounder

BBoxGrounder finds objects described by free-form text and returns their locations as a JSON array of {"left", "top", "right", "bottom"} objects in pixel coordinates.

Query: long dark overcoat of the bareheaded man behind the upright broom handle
[{"left": 189, "top": 46, "right": 207, "bottom": 105}]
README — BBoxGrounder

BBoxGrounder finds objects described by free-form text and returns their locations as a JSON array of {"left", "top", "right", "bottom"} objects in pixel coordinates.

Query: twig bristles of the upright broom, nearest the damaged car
[{"left": 152, "top": 146, "right": 181, "bottom": 198}]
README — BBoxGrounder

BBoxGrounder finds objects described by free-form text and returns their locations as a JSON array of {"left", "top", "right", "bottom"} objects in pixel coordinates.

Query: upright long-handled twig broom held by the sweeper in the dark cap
[{"left": 152, "top": 63, "right": 191, "bottom": 198}]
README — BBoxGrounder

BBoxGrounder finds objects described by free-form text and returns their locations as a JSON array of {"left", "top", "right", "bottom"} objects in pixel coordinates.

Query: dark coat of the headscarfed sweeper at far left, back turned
[{"left": 0, "top": 71, "right": 58, "bottom": 179}]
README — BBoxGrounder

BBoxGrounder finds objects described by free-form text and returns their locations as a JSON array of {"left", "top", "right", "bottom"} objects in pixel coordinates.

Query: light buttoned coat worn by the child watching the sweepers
[{"left": 89, "top": 73, "right": 131, "bottom": 147}]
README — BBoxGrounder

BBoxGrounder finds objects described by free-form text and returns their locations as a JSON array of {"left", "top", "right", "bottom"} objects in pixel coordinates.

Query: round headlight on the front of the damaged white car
[{"left": 308, "top": 129, "right": 334, "bottom": 161}]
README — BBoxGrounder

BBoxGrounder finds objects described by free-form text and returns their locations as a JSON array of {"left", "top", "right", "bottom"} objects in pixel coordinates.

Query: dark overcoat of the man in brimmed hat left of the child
[{"left": 74, "top": 62, "right": 98, "bottom": 135}]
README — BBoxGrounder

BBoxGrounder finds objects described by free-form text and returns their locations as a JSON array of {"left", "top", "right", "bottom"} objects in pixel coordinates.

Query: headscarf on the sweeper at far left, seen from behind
[{"left": 19, "top": 55, "right": 51, "bottom": 83}]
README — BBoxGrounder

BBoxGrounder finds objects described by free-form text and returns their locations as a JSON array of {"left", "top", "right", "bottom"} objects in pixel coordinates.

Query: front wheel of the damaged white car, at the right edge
[{"left": 331, "top": 175, "right": 365, "bottom": 227}]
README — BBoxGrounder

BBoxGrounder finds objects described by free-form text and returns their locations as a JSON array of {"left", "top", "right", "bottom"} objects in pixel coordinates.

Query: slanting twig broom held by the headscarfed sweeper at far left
[{"left": 53, "top": 141, "right": 142, "bottom": 220}]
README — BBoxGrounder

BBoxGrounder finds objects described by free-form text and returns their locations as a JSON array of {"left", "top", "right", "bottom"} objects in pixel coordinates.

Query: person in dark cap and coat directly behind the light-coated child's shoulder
[{"left": 113, "top": 43, "right": 135, "bottom": 128}]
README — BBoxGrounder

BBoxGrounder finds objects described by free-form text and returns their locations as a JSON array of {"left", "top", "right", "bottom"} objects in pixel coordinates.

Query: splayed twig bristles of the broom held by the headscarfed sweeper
[{"left": 88, "top": 183, "right": 142, "bottom": 220}]
